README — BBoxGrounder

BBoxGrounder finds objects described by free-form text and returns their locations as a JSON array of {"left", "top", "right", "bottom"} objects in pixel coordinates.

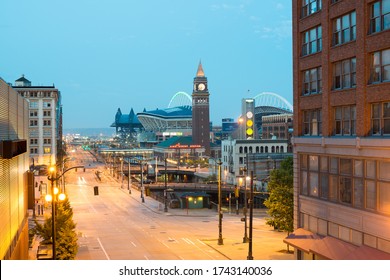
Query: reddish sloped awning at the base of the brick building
[{"left": 283, "top": 228, "right": 390, "bottom": 260}]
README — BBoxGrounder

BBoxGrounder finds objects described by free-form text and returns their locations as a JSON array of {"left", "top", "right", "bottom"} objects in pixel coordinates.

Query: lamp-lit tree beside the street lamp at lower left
[{"left": 34, "top": 199, "right": 78, "bottom": 260}]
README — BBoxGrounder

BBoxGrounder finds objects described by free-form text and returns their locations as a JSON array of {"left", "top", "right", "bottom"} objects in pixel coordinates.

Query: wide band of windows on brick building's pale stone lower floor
[{"left": 299, "top": 154, "right": 390, "bottom": 215}]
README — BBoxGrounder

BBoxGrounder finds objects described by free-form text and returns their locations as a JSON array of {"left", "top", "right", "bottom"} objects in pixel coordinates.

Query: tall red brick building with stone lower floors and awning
[{"left": 285, "top": 0, "right": 390, "bottom": 259}]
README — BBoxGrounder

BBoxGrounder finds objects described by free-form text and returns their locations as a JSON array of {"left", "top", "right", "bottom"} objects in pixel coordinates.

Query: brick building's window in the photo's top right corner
[{"left": 370, "top": 0, "right": 390, "bottom": 33}]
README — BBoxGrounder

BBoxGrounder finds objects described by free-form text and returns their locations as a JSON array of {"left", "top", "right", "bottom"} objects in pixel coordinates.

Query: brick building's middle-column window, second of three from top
[{"left": 333, "top": 58, "right": 356, "bottom": 89}]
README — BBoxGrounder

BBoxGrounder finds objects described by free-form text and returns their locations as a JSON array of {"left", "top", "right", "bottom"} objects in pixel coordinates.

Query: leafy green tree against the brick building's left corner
[{"left": 264, "top": 157, "right": 294, "bottom": 248}]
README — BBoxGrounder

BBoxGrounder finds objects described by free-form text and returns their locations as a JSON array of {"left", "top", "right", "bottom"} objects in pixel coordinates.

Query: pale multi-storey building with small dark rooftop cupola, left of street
[{"left": 13, "top": 76, "right": 62, "bottom": 166}]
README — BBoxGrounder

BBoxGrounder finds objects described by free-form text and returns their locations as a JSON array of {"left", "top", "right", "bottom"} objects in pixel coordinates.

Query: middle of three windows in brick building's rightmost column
[{"left": 370, "top": 49, "right": 390, "bottom": 83}]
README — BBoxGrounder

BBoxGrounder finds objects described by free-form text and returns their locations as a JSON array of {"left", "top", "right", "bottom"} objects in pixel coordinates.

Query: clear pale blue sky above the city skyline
[{"left": 0, "top": 0, "right": 292, "bottom": 129}]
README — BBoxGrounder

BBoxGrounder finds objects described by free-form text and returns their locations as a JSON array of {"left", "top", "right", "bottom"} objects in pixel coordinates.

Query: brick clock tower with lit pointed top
[{"left": 192, "top": 62, "right": 210, "bottom": 156}]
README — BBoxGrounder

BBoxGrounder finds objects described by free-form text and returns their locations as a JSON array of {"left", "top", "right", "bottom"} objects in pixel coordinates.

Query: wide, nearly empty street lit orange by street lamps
[{"left": 62, "top": 147, "right": 290, "bottom": 260}]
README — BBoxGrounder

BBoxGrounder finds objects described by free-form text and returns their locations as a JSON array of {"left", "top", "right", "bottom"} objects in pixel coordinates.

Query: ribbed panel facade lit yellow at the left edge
[{"left": 0, "top": 78, "right": 29, "bottom": 260}]
